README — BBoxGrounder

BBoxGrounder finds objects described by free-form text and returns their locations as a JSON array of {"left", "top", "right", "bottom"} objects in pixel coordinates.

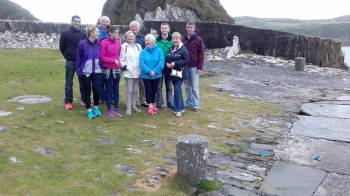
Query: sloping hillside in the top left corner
[{"left": 0, "top": 0, "right": 38, "bottom": 20}]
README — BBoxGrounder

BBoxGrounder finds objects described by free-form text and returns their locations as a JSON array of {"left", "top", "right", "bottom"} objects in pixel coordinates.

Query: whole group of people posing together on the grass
[{"left": 59, "top": 16, "right": 204, "bottom": 119}]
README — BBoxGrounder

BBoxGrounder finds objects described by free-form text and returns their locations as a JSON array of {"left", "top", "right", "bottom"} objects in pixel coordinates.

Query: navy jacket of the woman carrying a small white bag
[{"left": 165, "top": 44, "right": 190, "bottom": 80}]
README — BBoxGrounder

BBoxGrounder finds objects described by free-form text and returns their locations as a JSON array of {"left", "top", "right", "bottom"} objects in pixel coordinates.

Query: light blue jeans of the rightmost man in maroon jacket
[{"left": 185, "top": 67, "right": 199, "bottom": 109}]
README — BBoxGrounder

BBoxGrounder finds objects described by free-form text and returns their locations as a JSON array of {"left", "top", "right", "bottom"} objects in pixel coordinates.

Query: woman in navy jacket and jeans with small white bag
[{"left": 165, "top": 32, "right": 190, "bottom": 117}]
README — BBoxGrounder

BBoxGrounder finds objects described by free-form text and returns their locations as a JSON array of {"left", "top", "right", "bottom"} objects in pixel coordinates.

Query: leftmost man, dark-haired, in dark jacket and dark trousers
[{"left": 59, "top": 16, "right": 86, "bottom": 110}]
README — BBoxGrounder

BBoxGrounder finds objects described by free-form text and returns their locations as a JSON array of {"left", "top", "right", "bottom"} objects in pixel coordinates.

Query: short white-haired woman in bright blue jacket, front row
[{"left": 140, "top": 34, "right": 164, "bottom": 115}]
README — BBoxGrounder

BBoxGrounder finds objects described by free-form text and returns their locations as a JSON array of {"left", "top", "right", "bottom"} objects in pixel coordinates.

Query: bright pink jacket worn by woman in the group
[{"left": 100, "top": 38, "right": 121, "bottom": 69}]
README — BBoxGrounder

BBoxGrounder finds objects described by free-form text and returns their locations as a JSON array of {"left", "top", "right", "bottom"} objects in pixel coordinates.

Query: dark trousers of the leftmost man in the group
[{"left": 64, "top": 61, "right": 83, "bottom": 104}]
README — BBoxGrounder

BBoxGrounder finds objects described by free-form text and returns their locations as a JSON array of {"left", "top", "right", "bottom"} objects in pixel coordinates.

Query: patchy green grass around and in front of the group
[{"left": 0, "top": 49, "right": 281, "bottom": 195}]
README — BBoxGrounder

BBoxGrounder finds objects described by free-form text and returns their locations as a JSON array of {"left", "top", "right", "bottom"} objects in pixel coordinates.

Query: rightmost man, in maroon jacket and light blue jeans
[{"left": 182, "top": 22, "right": 204, "bottom": 112}]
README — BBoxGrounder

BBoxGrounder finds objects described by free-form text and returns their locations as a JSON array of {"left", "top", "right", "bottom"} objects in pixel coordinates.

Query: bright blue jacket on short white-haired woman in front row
[{"left": 140, "top": 46, "right": 164, "bottom": 79}]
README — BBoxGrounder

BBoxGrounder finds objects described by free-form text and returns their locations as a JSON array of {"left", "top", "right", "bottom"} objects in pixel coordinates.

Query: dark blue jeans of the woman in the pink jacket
[{"left": 105, "top": 70, "right": 120, "bottom": 110}]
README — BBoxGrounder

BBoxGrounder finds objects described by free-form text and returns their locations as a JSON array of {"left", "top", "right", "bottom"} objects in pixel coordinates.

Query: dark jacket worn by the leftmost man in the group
[{"left": 59, "top": 27, "right": 86, "bottom": 61}]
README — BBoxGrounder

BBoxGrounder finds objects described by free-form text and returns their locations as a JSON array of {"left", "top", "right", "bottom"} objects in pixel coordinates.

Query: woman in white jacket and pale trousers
[{"left": 120, "top": 31, "right": 142, "bottom": 115}]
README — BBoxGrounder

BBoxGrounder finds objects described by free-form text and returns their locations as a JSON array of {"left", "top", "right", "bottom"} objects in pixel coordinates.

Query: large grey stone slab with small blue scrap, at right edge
[{"left": 275, "top": 136, "right": 350, "bottom": 175}]
